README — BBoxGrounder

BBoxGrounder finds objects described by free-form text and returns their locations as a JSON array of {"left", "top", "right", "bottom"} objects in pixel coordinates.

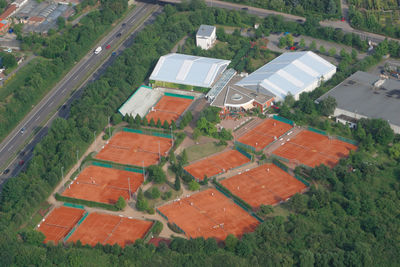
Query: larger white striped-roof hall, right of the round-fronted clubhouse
[{"left": 236, "top": 51, "right": 336, "bottom": 101}]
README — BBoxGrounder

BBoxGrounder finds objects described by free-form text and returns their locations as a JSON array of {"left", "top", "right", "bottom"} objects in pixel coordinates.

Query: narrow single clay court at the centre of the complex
[{"left": 184, "top": 150, "right": 250, "bottom": 181}]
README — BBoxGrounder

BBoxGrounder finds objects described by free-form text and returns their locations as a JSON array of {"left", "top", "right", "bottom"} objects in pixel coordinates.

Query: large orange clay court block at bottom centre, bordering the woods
[{"left": 158, "top": 188, "right": 259, "bottom": 240}]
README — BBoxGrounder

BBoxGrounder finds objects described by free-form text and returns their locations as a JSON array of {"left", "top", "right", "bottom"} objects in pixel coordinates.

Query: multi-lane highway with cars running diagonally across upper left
[{"left": 0, "top": 3, "right": 161, "bottom": 185}]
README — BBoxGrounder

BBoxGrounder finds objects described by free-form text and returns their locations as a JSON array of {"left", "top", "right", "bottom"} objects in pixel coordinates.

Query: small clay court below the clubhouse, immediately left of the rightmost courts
[{"left": 237, "top": 119, "right": 293, "bottom": 151}]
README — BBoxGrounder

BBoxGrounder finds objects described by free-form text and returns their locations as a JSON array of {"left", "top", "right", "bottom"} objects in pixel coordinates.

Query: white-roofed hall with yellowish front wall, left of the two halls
[{"left": 150, "top": 53, "right": 231, "bottom": 88}]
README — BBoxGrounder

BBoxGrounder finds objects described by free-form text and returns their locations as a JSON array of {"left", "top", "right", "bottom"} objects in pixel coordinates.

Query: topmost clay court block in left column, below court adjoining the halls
[{"left": 96, "top": 132, "right": 172, "bottom": 166}]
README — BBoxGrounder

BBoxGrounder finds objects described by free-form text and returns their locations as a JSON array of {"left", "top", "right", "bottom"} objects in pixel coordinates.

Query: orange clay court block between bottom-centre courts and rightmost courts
[{"left": 220, "top": 163, "right": 307, "bottom": 208}]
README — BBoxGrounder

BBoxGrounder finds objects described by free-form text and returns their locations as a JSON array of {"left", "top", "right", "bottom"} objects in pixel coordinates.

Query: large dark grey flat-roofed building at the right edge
[{"left": 317, "top": 71, "right": 400, "bottom": 133}]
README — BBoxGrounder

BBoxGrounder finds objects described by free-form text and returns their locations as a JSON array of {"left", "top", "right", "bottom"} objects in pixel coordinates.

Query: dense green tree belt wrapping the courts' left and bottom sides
[{"left": 0, "top": 4, "right": 400, "bottom": 266}]
